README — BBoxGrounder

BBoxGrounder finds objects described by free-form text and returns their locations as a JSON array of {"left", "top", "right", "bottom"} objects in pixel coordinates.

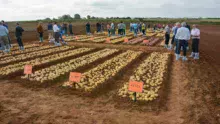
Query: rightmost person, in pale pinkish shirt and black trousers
[{"left": 190, "top": 25, "right": 200, "bottom": 59}]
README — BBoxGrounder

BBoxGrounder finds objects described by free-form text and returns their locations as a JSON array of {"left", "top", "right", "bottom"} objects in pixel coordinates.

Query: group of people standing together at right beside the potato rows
[{"left": 165, "top": 22, "right": 200, "bottom": 61}]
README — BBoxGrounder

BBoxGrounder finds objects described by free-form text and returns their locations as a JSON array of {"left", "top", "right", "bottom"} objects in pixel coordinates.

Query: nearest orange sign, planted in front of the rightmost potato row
[{"left": 128, "top": 81, "right": 144, "bottom": 93}]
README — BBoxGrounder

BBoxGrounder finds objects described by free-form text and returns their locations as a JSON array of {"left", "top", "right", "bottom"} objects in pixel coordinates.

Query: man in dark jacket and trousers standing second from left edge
[{"left": 15, "top": 23, "right": 24, "bottom": 50}]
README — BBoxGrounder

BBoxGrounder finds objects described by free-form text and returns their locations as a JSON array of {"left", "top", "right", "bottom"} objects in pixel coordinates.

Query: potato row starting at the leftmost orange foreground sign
[{"left": 22, "top": 49, "right": 118, "bottom": 83}]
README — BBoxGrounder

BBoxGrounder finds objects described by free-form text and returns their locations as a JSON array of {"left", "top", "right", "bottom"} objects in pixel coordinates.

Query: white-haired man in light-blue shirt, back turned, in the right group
[{"left": 175, "top": 22, "right": 190, "bottom": 61}]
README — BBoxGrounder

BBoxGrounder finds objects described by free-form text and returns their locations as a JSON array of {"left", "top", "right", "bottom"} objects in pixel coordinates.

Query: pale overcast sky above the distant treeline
[{"left": 0, "top": 0, "right": 220, "bottom": 21}]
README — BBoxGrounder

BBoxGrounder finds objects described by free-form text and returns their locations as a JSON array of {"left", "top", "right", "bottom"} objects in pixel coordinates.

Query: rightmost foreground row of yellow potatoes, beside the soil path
[{"left": 118, "top": 52, "right": 170, "bottom": 101}]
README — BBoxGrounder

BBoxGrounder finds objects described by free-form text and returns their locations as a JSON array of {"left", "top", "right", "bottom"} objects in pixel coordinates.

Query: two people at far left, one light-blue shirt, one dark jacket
[{"left": 0, "top": 21, "right": 24, "bottom": 53}]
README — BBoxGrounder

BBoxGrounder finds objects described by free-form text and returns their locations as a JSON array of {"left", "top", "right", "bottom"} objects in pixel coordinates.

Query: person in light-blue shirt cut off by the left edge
[{"left": 0, "top": 22, "right": 10, "bottom": 53}]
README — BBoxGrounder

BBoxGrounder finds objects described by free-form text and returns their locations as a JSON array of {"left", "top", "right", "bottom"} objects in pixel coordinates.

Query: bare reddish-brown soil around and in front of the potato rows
[{"left": 0, "top": 26, "right": 220, "bottom": 124}]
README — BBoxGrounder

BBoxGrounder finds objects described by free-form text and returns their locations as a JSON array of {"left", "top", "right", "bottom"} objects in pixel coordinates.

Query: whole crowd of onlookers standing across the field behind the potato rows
[{"left": 0, "top": 21, "right": 200, "bottom": 61}]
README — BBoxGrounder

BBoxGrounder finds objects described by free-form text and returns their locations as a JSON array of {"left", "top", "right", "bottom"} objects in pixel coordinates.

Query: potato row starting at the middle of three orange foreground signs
[{"left": 63, "top": 51, "right": 142, "bottom": 92}]
